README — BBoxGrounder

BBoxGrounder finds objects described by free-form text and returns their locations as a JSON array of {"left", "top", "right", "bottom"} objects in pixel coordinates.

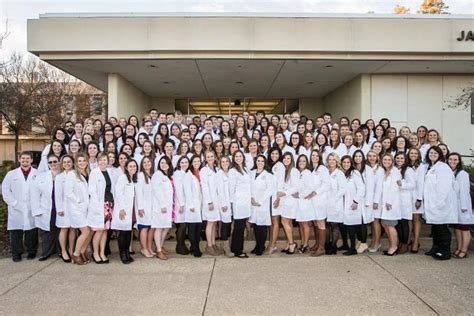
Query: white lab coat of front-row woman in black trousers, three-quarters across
[{"left": 344, "top": 170, "right": 365, "bottom": 225}]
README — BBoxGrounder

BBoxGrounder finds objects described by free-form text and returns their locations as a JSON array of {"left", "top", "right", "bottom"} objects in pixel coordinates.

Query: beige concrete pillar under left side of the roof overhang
[{"left": 108, "top": 73, "right": 151, "bottom": 119}]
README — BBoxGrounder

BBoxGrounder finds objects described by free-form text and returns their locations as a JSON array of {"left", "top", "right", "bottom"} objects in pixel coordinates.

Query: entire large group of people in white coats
[{"left": 2, "top": 109, "right": 474, "bottom": 265}]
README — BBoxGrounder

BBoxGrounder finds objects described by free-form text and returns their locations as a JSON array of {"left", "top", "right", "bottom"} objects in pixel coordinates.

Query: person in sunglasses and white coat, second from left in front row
[{"left": 30, "top": 154, "right": 60, "bottom": 261}]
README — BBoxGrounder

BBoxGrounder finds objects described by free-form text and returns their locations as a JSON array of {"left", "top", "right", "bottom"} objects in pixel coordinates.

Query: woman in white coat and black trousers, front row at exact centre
[{"left": 229, "top": 150, "right": 251, "bottom": 258}]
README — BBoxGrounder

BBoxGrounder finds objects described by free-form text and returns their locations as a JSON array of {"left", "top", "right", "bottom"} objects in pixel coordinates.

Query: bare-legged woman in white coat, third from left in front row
[{"left": 54, "top": 155, "right": 76, "bottom": 263}]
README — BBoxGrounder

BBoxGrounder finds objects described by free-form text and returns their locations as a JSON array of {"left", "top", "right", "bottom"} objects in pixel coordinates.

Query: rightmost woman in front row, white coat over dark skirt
[{"left": 448, "top": 153, "right": 474, "bottom": 259}]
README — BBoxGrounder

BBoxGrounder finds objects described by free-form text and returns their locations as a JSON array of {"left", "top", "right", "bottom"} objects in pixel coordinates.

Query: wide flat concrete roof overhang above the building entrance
[{"left": 28, "top": 14, "right": 474, "bottom": 98}]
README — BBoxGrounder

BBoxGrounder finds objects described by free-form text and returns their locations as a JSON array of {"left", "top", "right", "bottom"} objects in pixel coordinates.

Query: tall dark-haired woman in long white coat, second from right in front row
[{"left": 423, "top": 146, "right": 459, "bottom": 260}]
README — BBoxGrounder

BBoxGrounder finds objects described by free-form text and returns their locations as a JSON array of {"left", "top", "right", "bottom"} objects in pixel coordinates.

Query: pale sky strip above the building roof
[{"left": 0, "top": 0, "right": 474, "bottom": 59}]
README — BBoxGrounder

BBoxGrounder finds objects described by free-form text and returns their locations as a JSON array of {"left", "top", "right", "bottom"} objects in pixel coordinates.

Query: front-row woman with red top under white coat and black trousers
[{"left": 184, "top": 155, "right": 203, "bottom": 258}]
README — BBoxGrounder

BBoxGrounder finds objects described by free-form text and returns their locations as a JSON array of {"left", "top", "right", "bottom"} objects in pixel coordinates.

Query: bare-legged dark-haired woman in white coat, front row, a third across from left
[{"left": 151, "top": 156, "right": 175, "bottom": 260}]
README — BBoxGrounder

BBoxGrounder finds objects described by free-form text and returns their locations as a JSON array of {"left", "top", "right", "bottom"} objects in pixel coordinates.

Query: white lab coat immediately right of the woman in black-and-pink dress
[{"left": 110, "top": 174, "right": 136, "bottom": 231}]
